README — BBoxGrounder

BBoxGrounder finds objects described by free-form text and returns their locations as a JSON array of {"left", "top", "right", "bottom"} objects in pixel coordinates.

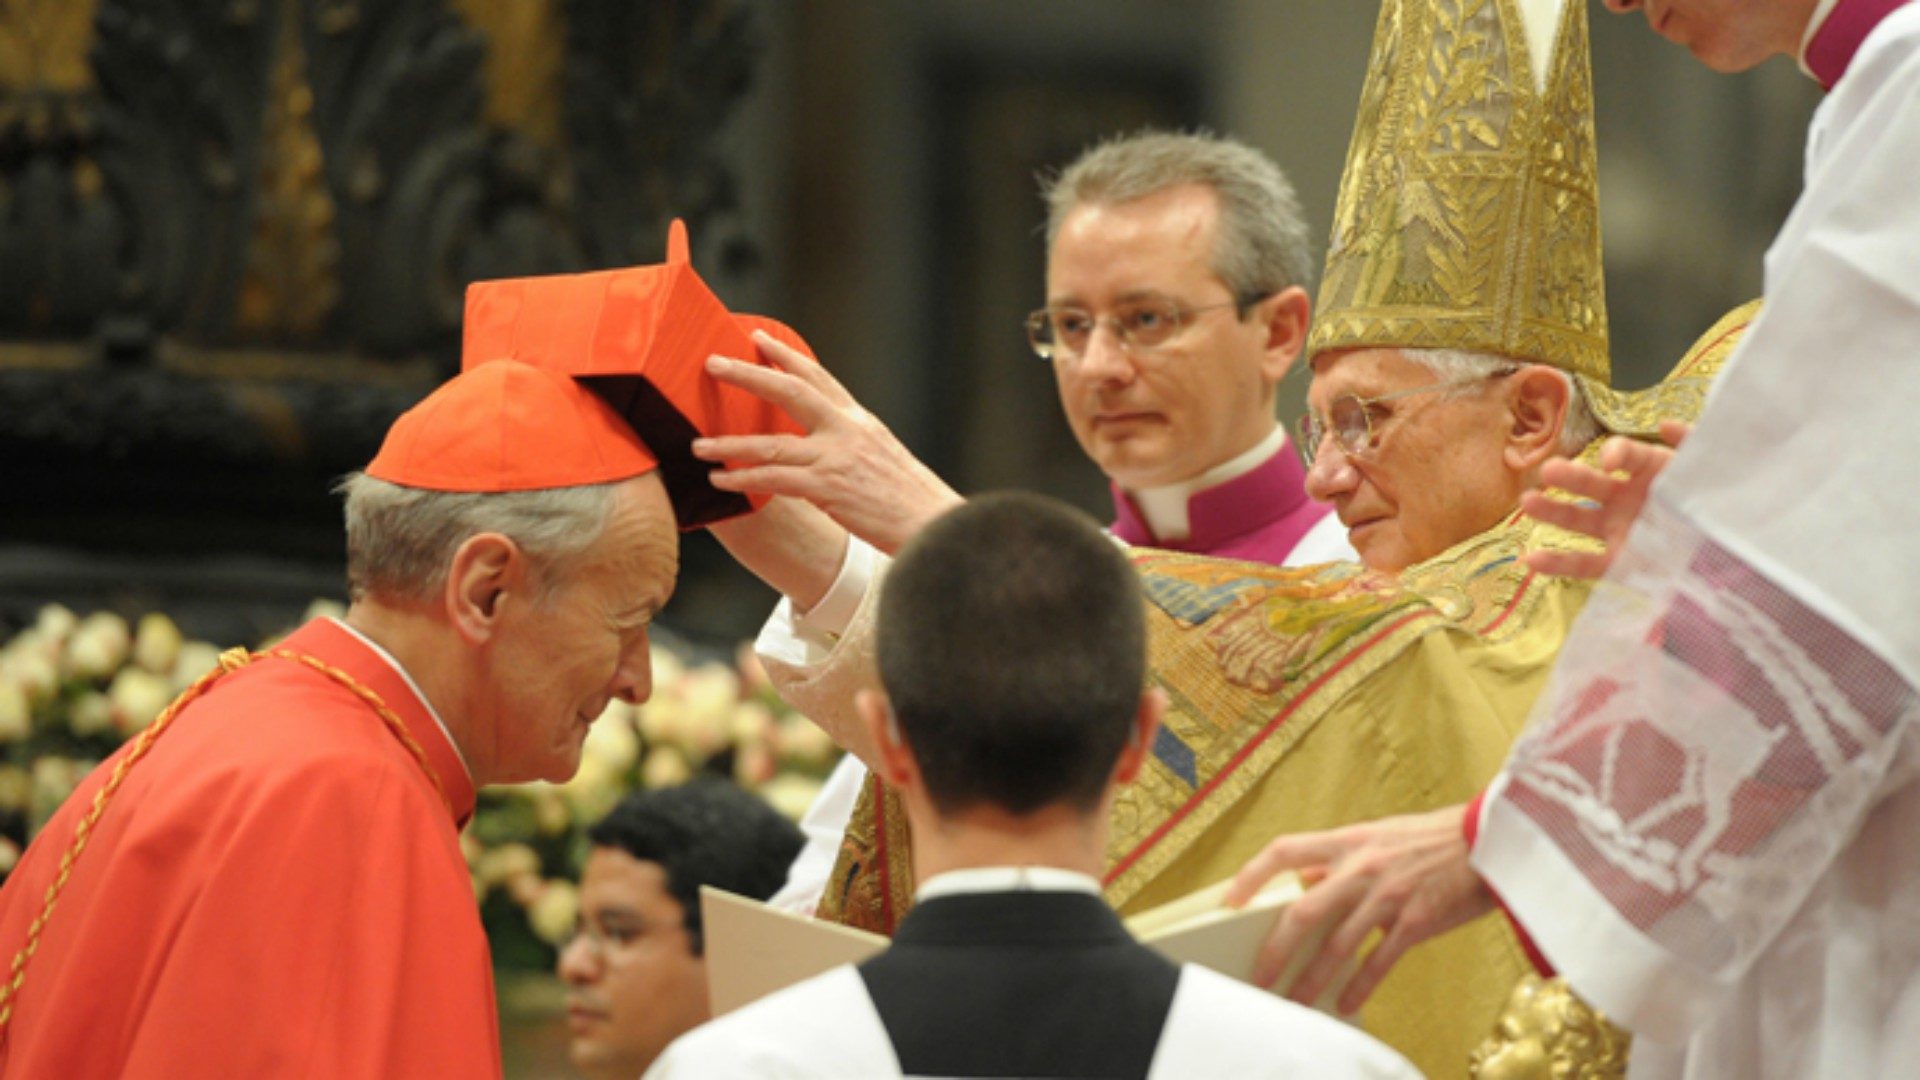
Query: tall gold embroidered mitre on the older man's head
[{"left": 1309, "top": 0, "right": 1689, "bottom": 432}]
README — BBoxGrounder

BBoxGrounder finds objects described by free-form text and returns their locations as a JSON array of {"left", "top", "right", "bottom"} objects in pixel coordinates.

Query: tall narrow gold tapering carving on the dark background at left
[{"left": 234, "top": 0, "right": 340, "bottom": 340}]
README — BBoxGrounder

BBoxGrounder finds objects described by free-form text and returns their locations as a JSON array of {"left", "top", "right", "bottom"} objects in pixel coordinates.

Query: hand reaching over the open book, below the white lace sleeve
[{"left": 1225, "top": 805, "right": 1494, "bottom": 1013}]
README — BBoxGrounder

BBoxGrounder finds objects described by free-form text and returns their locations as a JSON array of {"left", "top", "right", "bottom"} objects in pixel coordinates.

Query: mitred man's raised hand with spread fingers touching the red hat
[{"left": 693, "top": 331, "right": 962, "bottom": 555}]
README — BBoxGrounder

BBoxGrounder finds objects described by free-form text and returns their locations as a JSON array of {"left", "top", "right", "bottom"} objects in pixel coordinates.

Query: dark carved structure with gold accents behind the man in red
[{"left": 0, "top": 0, "right": 755, "bottom": 632}]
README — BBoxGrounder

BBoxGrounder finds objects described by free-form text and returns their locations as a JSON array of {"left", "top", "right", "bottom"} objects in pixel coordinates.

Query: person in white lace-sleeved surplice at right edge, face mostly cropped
[{"left": 1236, "top": 0, "right": 1920, "bottom": 1080}]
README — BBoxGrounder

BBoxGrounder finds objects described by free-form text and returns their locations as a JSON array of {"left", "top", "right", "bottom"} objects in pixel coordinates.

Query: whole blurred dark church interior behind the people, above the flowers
[{"left": 0, "top": 0, "right": 1816, "bottom": 644}]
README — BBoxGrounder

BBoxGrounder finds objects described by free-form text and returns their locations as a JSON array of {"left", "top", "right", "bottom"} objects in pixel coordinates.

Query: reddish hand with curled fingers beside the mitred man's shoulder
[{"left": 1521, "top": 421, "right": 1692, "bottom": 578}]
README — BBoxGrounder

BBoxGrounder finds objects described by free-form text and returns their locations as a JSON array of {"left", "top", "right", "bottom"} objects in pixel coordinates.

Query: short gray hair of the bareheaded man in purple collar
[{"left": 1041, "top": 131, "right": 1313, "bottom": 306}]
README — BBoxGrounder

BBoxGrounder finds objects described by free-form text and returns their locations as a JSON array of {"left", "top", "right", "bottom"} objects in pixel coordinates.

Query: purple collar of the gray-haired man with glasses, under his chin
[{"left": 1112, "top": 446, "right": 1332, "bottom": 567}]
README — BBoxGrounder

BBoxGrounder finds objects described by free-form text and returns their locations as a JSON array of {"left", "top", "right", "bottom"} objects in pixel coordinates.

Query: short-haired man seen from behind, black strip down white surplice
[{"left": 649, "top": 494, "right": 1417, "bottom": 1078}]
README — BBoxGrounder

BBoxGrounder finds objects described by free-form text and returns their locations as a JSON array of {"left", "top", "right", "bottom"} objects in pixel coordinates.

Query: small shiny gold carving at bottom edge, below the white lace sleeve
[{"left": 1467, "top": 974, "right": 1632, "bottom": 1080}]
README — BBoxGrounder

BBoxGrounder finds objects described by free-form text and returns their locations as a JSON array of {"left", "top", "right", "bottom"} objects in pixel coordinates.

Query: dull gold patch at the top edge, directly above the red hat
[{"left": 451, "top": 0, "right": 566, "bottom": 148}]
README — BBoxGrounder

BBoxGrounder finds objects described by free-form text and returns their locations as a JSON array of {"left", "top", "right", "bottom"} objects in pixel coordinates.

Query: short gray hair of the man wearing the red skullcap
[{"left": 334, "top": 473, "right": 614, "bottom": 601}]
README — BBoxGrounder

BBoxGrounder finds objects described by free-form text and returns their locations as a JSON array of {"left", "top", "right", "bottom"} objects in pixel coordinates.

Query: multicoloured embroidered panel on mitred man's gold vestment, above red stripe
[{"left": 1106, "top": 519, "right": 1576, "bottom": 907}]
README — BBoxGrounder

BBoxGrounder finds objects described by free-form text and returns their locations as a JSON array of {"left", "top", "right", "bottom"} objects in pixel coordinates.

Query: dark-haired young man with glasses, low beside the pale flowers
[{"left": 559, "top": 780, "right": 801, "bottom": 1080}]
